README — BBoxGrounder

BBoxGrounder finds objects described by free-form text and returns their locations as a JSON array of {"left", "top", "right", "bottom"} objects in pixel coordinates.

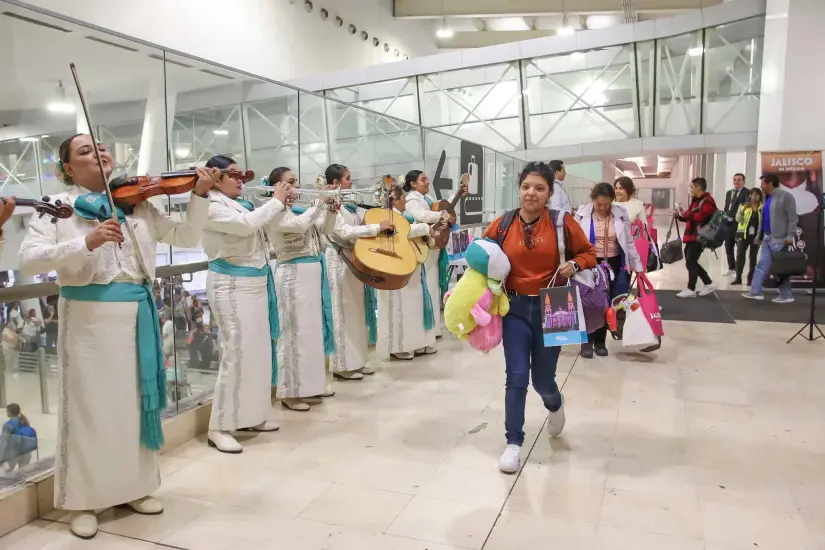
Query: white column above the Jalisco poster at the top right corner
[{"left": 757, "top": 0, "right": 825, "bottom": 151}]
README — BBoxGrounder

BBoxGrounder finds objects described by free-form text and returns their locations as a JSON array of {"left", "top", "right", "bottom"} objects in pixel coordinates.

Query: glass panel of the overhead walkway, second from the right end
[{"left": 655, "top": 31, "right": 704, "bottom": 136}]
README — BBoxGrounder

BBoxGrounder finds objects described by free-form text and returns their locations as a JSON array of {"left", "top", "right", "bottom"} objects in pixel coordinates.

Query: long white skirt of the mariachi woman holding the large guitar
[{"left": 326, "top": 247, "right": 369, "bottom": 372}]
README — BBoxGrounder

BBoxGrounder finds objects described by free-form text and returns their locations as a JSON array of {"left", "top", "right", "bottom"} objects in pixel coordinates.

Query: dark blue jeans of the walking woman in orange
[{"left": 502, "top": 293, "right": 561, "bottom": 445}]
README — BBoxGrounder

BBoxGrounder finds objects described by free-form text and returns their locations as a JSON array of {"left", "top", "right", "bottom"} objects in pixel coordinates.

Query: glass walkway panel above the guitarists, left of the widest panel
[{"left": 418, "top": 66, "right": 523, "bottom": 151}]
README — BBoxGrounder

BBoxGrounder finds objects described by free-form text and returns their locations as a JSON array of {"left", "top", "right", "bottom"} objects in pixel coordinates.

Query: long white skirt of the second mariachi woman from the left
[{"left": 206, "top": 271, "right": 272, "bottom": 431}]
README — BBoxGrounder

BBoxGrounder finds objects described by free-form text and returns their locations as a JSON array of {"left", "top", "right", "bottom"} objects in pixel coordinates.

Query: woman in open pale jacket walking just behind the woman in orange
[{"left": 576, "top": 182, "right": 644, "bottom": 359}]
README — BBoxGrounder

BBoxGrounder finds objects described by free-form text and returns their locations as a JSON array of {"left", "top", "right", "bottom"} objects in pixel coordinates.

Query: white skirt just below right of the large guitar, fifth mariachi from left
[{"left": 377, "top": 266, "right": 439, "bottom": 356}]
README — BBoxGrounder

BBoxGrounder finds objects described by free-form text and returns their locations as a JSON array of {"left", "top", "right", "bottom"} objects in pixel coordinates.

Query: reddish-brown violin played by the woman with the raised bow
[{"left": 110, "top": 168, "right": 255, "bottom": 206}]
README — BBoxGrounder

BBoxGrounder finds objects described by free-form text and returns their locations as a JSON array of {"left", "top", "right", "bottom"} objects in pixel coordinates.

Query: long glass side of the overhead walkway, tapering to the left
[{"left": 324, "top": 16, "right": 765, "bottom": 151}]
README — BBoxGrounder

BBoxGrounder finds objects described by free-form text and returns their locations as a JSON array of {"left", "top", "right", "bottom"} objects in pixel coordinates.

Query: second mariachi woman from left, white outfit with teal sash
[{"left": 203, "top": 155, "right": 288, "bottom": 453}]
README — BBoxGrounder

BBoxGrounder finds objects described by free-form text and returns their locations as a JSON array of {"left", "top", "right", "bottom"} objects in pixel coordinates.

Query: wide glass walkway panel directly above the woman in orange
[{"left": 522, "top": 44, "right": 639, "bottom": 148}]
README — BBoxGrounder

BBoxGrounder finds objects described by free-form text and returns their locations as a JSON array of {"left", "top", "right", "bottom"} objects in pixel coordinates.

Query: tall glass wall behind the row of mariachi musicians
[{"left": 0, "top": 2, "right": 524, "bottom": 488}]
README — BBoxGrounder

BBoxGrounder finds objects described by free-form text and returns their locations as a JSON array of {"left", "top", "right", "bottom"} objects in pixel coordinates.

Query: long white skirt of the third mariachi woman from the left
[{"left": 267, "top": 263, "right": 326, "bottom": 397}]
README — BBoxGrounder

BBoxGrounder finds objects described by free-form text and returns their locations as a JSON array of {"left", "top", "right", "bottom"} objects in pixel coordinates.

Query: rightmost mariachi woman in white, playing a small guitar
[{"left": 403, "top": 170, "right": 467, "bottom": 359}]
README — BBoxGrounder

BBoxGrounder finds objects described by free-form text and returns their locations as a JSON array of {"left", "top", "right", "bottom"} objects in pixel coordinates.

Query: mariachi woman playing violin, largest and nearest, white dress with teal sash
[{"left": 20, "top": 134, "right": 220, "bottom": 538}]
